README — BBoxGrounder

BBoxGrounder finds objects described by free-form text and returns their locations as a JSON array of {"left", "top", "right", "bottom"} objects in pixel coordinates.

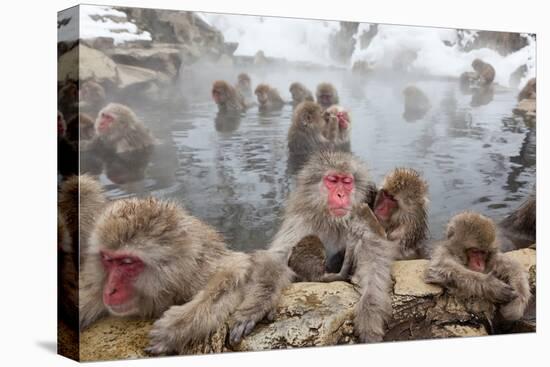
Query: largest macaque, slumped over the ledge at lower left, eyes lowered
[{"left": 80, "top": 198, "right": 291, "bottom": 354}]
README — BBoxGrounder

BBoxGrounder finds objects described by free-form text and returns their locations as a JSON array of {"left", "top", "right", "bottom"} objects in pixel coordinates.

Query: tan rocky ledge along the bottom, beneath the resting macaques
[{"left": 80, "top": 249, "right": 536, "bottom": 361}]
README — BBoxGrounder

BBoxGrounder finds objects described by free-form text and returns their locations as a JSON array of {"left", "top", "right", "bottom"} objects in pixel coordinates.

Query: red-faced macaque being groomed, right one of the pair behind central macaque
[{"left": 323, "top": 105, "right": 351, "bottom": 152}]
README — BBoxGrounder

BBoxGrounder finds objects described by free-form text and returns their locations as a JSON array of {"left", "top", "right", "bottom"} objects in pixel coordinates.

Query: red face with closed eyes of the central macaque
[{"left": 323, "top": 173, "right": 354, "bottom": 217}]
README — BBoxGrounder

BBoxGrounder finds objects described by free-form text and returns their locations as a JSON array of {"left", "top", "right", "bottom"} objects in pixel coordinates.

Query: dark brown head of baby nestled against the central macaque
[{"left": 288, "top": 235, "right": 326, "bottom": 282}]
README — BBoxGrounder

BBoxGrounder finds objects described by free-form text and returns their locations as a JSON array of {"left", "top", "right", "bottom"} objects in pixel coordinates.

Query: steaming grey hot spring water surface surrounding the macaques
[{"left": 87, "top": 71, "right": 536, "bottom": 250}]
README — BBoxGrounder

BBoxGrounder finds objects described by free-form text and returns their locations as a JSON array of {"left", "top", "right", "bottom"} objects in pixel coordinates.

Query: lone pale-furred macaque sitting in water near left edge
[{"left": 95, "top": 103, "right": 155, "bottom": 154}]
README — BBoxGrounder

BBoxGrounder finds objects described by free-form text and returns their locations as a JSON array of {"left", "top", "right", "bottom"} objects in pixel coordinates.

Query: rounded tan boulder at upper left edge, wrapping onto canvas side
[{"left": 57, "top": 44, "right": 118, "bottom": 84}]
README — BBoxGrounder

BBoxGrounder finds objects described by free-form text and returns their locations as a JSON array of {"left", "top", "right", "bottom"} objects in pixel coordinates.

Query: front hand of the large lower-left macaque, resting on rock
[{"left": 145, "top": 303, "right": 198, "bottom": 355}]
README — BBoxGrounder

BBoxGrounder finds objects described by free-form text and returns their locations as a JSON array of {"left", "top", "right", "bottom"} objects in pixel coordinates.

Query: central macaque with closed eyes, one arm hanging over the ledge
[{"left": 269, "top": 152, "right": 393, "bottom": 342}]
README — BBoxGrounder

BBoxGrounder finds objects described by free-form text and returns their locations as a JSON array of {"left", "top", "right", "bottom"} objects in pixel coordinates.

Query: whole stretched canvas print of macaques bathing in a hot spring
[{"left": 57, "top": 5, "right": 536, "bottom": 361}]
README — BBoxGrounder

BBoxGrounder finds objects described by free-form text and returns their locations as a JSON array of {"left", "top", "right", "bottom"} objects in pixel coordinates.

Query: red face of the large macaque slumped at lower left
[{"left": 100, "top": 250, "right": 145, "bottom": 315}]
